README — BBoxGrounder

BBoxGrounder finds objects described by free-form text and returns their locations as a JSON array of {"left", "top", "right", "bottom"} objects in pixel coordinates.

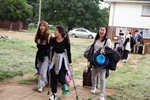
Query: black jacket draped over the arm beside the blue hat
[{"left": 105, "top": 47, "right": 120, "bottom": 70}]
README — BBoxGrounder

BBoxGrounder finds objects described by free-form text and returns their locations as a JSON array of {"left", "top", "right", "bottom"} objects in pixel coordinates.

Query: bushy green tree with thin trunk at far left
[{"left": 0, "top": 0, "right": 32, "bottom": 29}]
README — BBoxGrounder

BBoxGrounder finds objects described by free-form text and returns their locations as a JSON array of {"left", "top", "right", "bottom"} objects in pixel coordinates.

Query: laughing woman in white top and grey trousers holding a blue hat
[{"left": 91, "top": 26, "right": 111, "bottom": 100}]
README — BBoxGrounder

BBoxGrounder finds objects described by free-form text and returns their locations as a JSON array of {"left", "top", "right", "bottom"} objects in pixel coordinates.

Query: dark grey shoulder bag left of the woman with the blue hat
[{"left": 84, "top": 40, "right": 96, "bottom": 61}]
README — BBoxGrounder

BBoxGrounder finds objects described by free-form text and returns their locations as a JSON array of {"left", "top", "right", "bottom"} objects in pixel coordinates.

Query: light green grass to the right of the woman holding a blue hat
[{"left": 106, "top": 54, "right": 150, "bottom": 100}]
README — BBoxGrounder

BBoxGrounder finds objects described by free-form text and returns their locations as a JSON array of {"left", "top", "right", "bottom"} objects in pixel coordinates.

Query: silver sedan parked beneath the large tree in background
[{"left": 69, "top": 28, "right": 96, "bottom": 39}]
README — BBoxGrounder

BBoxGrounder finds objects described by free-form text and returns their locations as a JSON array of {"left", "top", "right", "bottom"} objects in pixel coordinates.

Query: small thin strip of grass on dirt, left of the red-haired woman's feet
[{"left": 18, "top": 77, "right": 38, "bottom": 84}]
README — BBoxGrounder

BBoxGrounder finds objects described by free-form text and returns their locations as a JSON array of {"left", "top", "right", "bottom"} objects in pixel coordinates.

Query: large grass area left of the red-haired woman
[{"left": 0, "top": 38, "right": 36, "bottom": 80}]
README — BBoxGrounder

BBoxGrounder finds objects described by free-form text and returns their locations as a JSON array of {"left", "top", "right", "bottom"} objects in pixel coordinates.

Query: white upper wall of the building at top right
[{"left": 109, "top": 2, "right": 150, "bottom": 28}]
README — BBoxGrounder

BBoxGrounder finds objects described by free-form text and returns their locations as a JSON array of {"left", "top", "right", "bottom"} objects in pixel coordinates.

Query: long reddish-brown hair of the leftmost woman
[{"left": 34, "top": 21, "right": 52, "bottom": 43}]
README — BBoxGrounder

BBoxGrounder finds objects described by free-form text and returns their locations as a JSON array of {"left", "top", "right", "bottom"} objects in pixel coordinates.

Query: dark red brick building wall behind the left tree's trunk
[{"left": 0, "top": 21, "right": 28, "bottom": 30}]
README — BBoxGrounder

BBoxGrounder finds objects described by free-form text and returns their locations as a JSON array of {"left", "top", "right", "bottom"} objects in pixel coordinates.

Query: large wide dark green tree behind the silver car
[{"left": 33, "top": 0, "right": 107, "bottom": 30}]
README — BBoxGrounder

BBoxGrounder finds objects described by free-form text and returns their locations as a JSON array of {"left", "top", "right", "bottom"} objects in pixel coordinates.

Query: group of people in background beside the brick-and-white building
[{"left": 114, "top": 29, "right": 144, "bottom": 62}]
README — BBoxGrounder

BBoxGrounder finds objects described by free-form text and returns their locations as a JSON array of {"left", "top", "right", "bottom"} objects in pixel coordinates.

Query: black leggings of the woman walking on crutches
[{"left": 50, "top": 61, "right": 67, "bottom": 93}]
